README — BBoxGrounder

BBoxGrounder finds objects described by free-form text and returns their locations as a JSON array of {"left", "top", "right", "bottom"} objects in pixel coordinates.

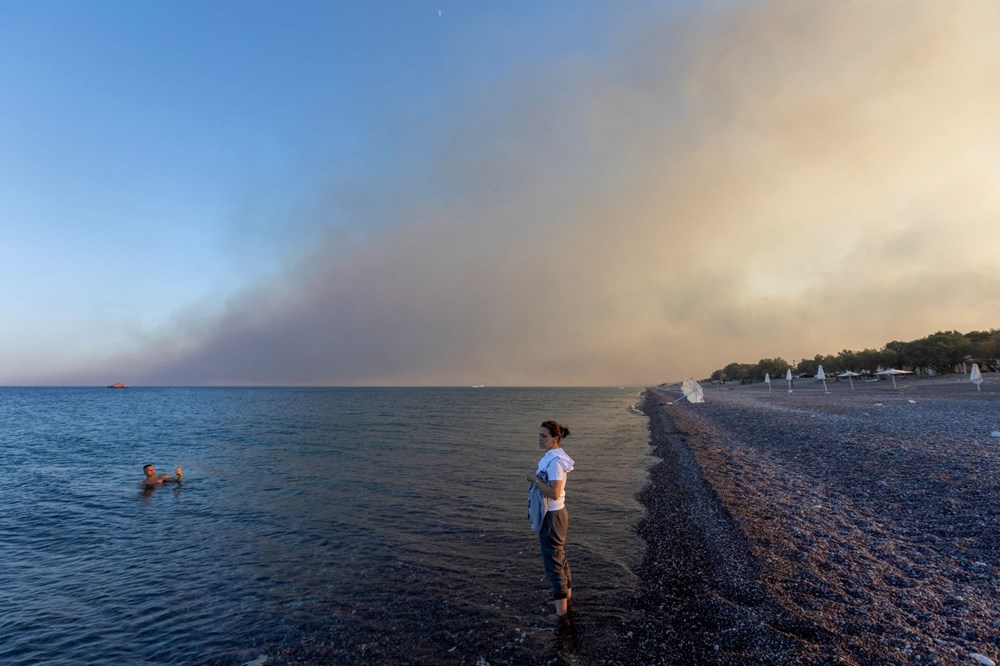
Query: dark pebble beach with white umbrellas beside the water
[{"left": 621, "top": 376, "right": 1000, "bottom": 664}]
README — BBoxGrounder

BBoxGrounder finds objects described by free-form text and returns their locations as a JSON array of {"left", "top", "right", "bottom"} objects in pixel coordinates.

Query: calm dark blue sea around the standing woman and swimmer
[{"left": 0, "top": 388, "right": 650, "bottom": 664}]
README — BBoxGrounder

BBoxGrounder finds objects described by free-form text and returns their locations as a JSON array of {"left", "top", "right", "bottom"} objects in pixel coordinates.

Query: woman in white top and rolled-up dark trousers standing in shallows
[{"left": 528, "top": 421, "right": 573, "bottom": 618}]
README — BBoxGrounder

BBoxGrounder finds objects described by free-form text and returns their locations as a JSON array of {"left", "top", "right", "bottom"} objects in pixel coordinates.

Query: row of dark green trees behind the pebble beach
[{"left": 711, "top": 329, "right": 1000, "bottom": 383}]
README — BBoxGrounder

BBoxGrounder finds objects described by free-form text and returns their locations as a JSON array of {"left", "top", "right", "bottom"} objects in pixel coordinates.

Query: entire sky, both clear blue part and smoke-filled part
[{"left": 0, "top": 0, "right": 1000, "bottom": 386}]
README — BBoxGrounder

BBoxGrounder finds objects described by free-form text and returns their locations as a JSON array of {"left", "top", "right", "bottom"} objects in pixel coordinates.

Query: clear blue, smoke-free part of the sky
[{"left": 0, "top": 1, "right": 632, "bottom": 375}]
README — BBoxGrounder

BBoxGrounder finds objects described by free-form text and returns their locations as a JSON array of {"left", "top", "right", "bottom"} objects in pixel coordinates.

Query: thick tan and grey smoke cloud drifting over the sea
[{"left": 113, "top": 2, "right": 1000, "bottom": 385}]
